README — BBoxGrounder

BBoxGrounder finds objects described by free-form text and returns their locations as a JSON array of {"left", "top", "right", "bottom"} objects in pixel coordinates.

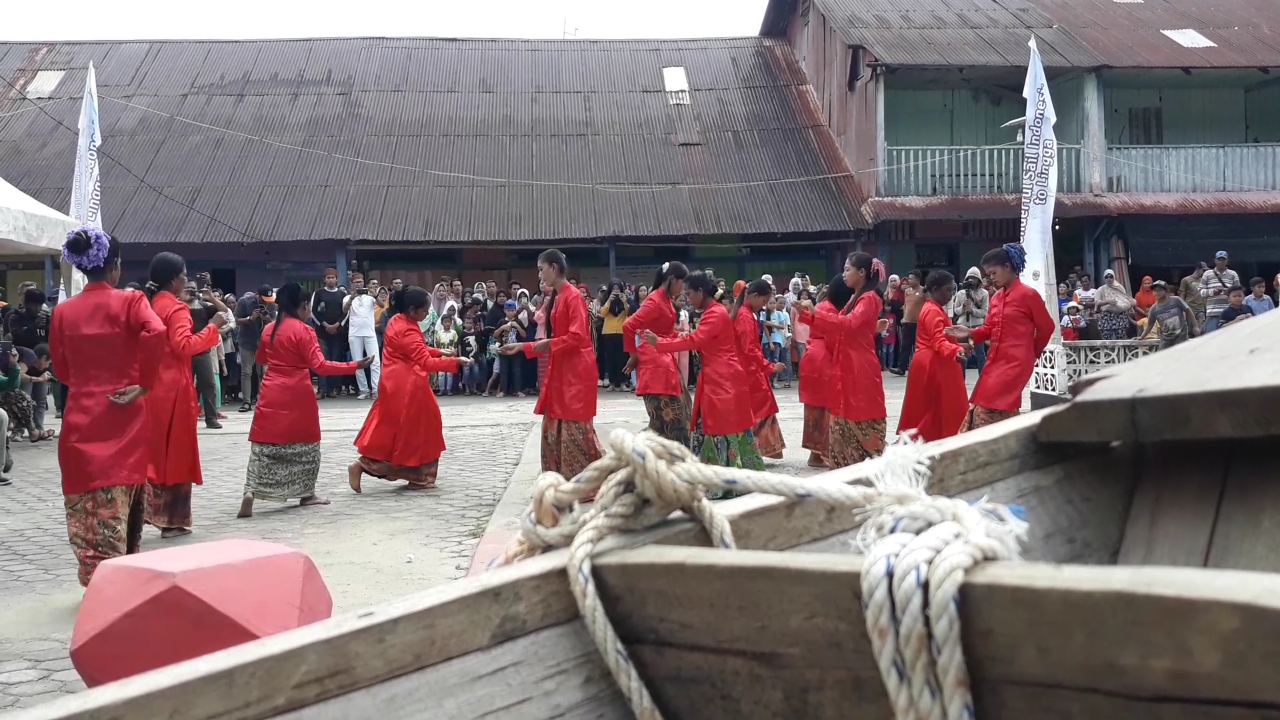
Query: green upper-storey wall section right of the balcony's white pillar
[{"left": 1105, "top": 87, "right": 1280, "bottom": 145}]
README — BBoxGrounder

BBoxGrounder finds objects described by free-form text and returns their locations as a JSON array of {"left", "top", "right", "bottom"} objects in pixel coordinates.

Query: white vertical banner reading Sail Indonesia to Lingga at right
[{"left": 1021, "top": 37, "right": 1057, "bottom": 325}]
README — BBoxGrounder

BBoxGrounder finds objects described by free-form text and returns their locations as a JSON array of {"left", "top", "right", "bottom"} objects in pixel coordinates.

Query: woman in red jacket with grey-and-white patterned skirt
[{"left": 236, "top": 282, "right": 374, "bottom": 518}]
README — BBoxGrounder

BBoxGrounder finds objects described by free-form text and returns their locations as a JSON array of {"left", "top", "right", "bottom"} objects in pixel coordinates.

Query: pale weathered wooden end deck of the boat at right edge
[{"left": 1038, "top": 314, "right": 1280, "bottom": 442}]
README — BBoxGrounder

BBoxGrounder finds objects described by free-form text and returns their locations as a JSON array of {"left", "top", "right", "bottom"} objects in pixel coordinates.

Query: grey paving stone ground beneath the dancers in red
[{"left": 0, "top": 373, "right": 1025, "bottom": 716}]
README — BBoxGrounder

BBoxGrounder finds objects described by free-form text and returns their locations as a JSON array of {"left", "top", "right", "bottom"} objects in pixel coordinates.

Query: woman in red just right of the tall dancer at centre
[{"left": 622, "top": 263, "right": 689, "bottom": 447}]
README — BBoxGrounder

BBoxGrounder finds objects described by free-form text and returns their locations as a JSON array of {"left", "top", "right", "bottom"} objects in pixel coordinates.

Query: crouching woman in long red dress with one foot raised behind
[{"left": 347, "top": 287, "right": 471, "bottom": 492}]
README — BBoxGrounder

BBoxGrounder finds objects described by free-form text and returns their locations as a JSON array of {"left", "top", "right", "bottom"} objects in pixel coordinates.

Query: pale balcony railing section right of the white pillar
[{"left": 1106, "top": 143, "right": 1280, "bottom": 192}]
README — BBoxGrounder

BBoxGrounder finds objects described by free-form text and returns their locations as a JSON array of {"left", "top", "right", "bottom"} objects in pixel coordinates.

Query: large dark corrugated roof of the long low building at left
[{"left": 0, "top": 37, "right": 867, "bottom": 242}]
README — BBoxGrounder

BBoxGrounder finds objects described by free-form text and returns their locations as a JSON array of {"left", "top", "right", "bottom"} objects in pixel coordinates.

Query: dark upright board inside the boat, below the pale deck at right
[{"left": 1117, "top": 442, "right": 1226, "bottom": 568}]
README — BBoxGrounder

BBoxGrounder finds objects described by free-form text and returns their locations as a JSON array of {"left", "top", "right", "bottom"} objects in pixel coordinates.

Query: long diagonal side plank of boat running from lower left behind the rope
[{"left": 14, "top": 407, "right": 1069, "bottom": 720}]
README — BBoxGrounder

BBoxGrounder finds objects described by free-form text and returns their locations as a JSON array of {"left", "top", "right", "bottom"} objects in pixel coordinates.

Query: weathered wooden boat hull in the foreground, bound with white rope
[{"left": 18, "top": 407, "right": 1280, "bottom": 720}]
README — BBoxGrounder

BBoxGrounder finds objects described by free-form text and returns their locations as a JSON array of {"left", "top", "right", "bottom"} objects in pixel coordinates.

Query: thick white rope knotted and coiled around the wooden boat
[{"left": 497, "top": 429, "right": 1027, "bottom": 720}]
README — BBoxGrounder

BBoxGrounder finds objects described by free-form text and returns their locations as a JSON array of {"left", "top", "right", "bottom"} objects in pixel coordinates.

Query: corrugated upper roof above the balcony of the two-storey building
[{"left": 783, "top": 0, "right": 1280, "bottom": 68}]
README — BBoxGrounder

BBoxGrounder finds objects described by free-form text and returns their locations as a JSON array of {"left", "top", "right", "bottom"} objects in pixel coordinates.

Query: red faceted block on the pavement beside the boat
[{"left": 70, "top": 539, "right": 333, "bottom": 687}]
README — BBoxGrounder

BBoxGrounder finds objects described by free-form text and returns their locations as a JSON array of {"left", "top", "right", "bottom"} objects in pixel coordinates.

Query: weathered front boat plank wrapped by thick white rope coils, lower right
[{"left": 596, "top": 546, "right": 1280, "bottom": 720}]
